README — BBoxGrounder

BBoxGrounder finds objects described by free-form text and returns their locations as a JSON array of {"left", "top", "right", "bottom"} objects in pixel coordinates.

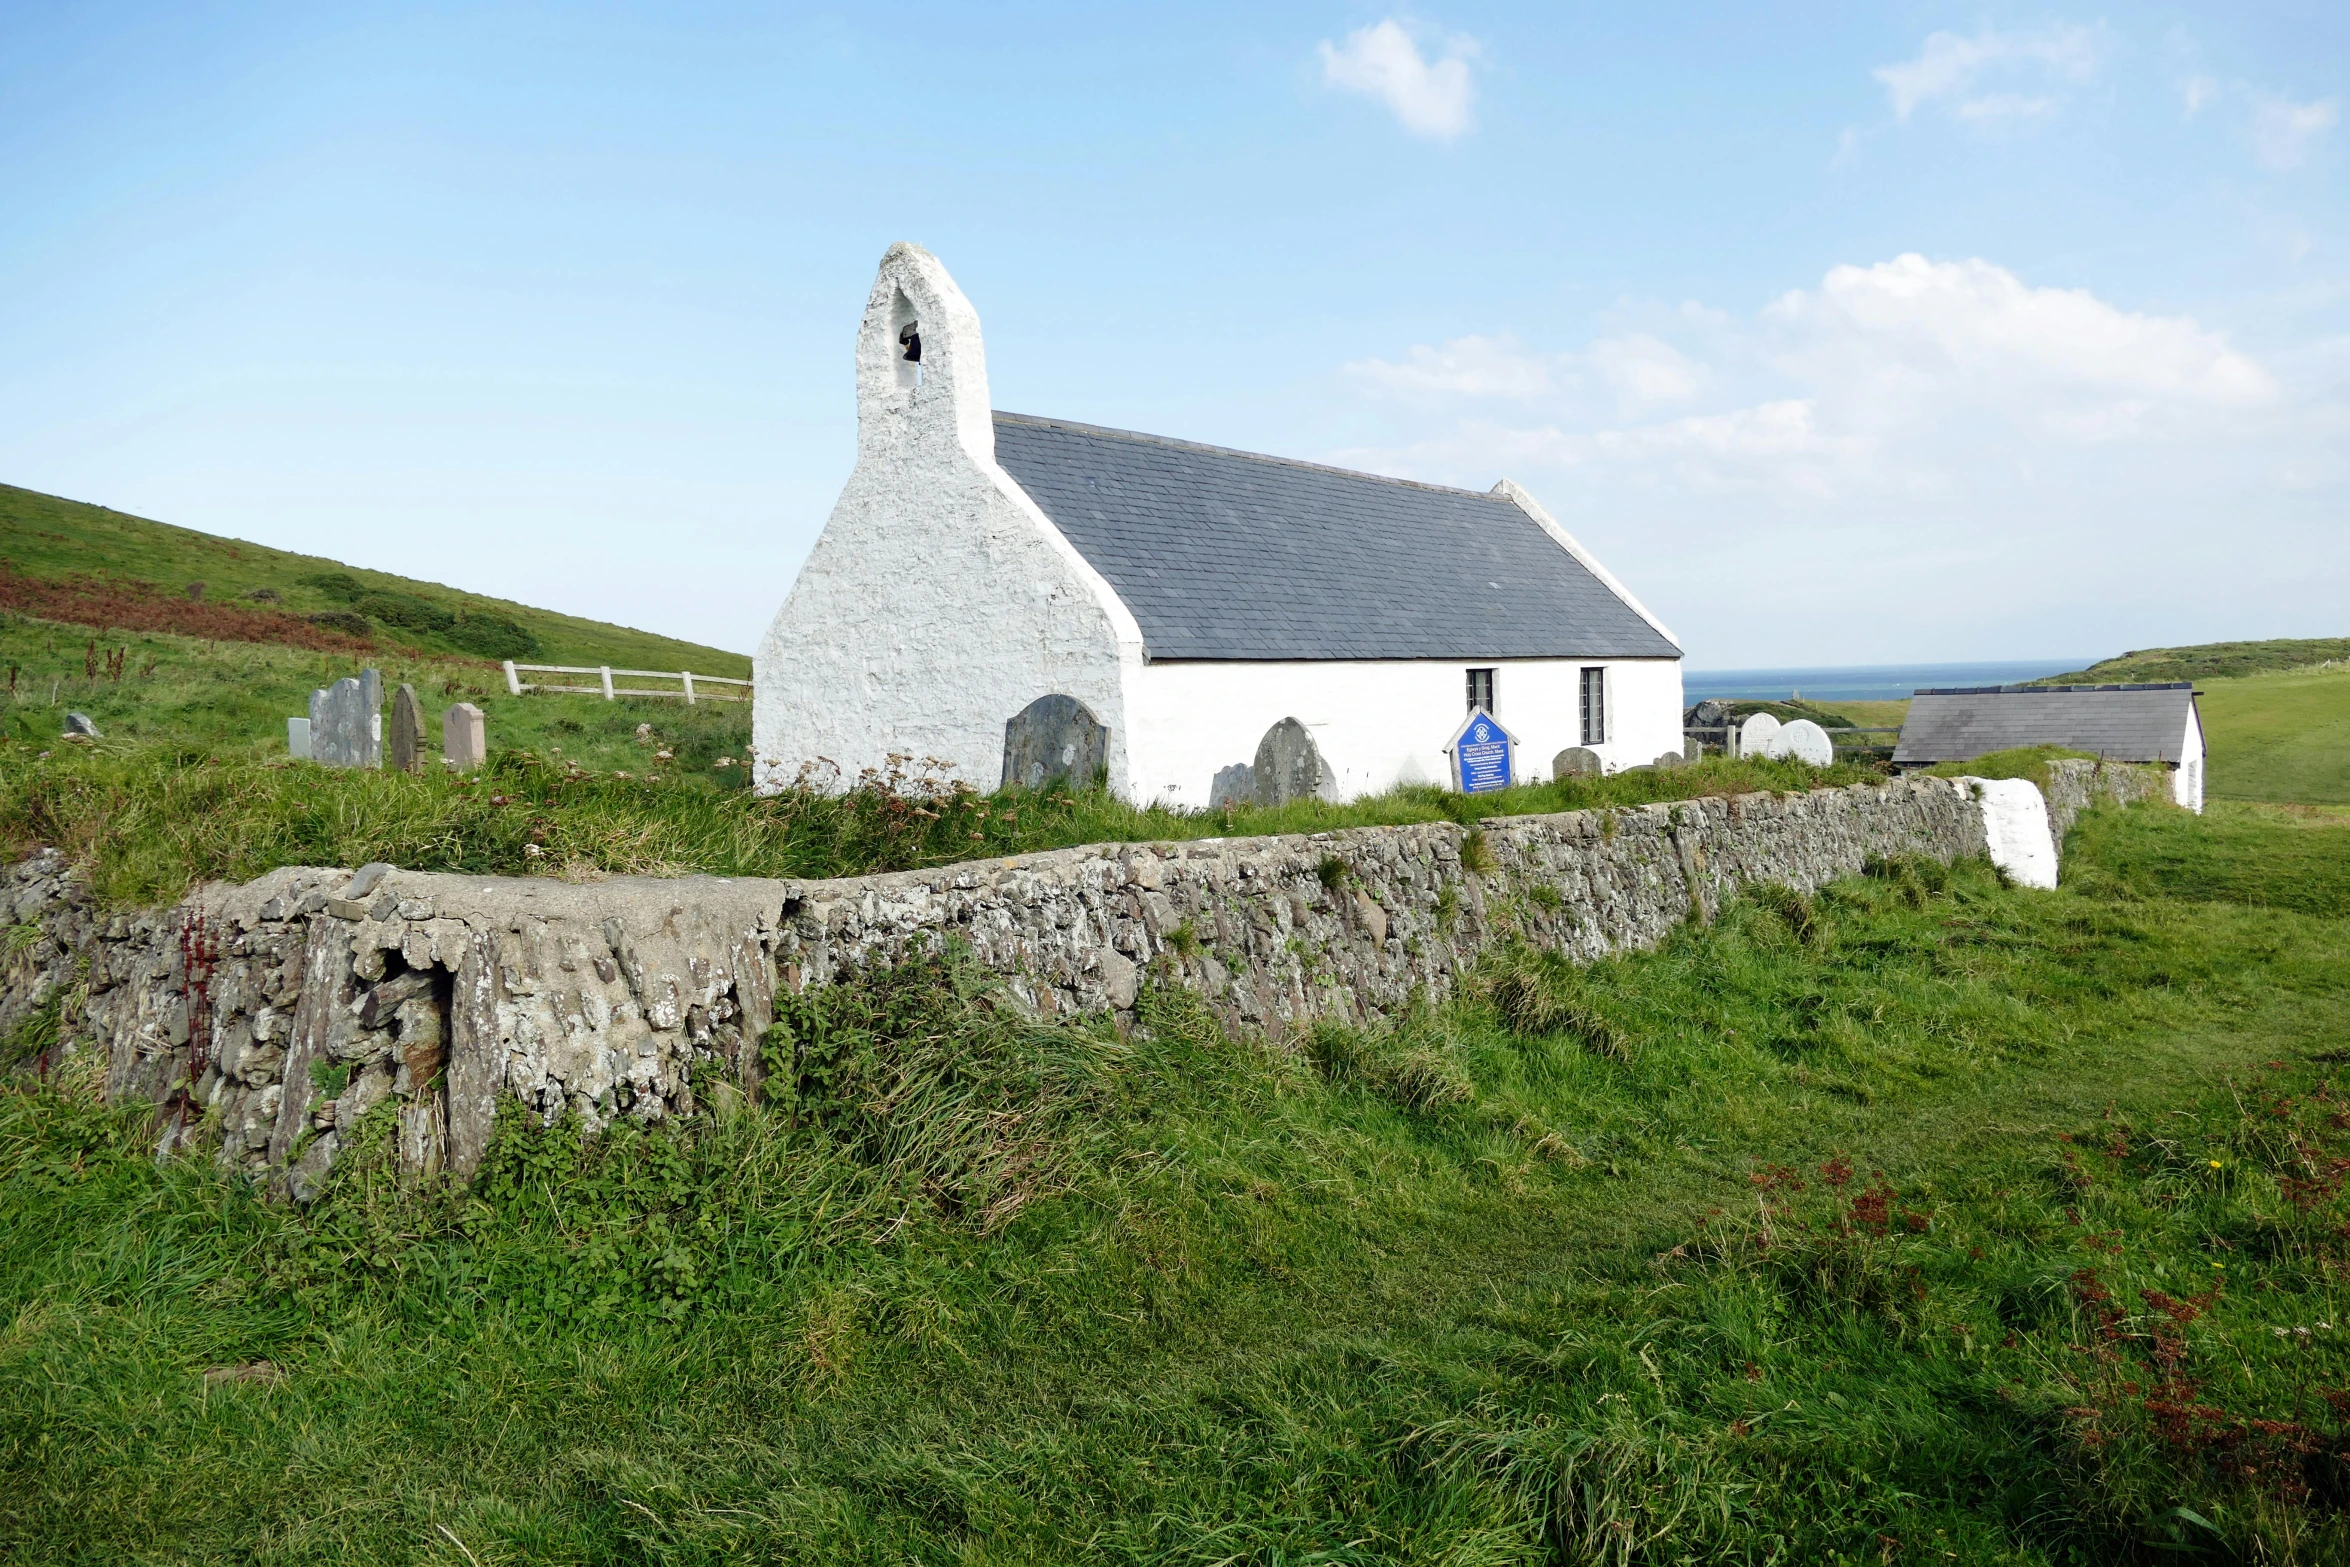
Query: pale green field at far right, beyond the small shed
[{"left": 2197, "top": 670, "right": 2350, "bottom": 806}]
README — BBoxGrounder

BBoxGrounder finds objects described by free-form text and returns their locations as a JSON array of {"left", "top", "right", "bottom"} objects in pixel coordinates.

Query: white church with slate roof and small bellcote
[{"left": 752, "top": 244, "right": 1683, "bottom": 808}]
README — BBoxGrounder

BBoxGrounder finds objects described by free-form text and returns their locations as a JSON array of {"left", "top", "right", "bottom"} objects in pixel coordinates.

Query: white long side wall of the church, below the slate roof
[{"left": 1126, "top": 658, "right": 1680, "bottom": 808}]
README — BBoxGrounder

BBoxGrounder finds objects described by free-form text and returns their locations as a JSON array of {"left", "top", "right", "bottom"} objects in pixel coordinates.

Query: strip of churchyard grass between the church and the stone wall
[{"left": 0, "top": 732, "right": 1868, "bottom": 904}]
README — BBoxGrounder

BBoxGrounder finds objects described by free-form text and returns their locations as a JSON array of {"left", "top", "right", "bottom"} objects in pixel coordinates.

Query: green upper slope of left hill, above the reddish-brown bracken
[{"left": 0, "top": 484, "right": 750, "bottom": 679}]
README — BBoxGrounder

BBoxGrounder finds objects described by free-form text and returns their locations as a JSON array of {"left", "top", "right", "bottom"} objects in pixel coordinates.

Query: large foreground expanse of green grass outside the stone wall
[{"left": 0, "top": 808, "right": 2350, "bottom": 1567}]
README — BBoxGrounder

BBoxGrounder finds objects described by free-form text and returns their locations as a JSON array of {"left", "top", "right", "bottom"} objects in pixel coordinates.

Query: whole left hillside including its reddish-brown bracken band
[{"left": 0, "top": 484, "right": 750, "bottom": 677}]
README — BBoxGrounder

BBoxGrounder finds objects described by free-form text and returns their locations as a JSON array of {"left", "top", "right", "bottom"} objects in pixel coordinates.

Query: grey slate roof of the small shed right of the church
[{"left": 1894, "top": 681, "right": 2195, "bottom": 766}]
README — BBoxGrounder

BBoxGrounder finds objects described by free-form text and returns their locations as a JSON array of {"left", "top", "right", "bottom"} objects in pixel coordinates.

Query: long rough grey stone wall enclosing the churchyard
[{"left": 0, "top": 778, "right": 1986, "bottom": 1198}]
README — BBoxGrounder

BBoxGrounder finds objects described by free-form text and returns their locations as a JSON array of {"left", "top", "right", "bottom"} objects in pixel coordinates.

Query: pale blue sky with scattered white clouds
[{"left": 0, "top": 0, "right": 2350, "bottom": 670}]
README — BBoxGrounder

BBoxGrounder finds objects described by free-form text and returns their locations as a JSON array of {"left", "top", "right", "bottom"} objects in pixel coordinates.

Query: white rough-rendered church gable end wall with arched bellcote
[{"left": 752, "top": 244, "right": 1142, "bottom": 792}]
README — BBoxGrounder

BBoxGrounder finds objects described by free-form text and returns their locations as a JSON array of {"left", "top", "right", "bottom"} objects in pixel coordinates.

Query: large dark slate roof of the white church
[{"left": 996, "top": 413, "right": 1680, "bottom": 660}]
